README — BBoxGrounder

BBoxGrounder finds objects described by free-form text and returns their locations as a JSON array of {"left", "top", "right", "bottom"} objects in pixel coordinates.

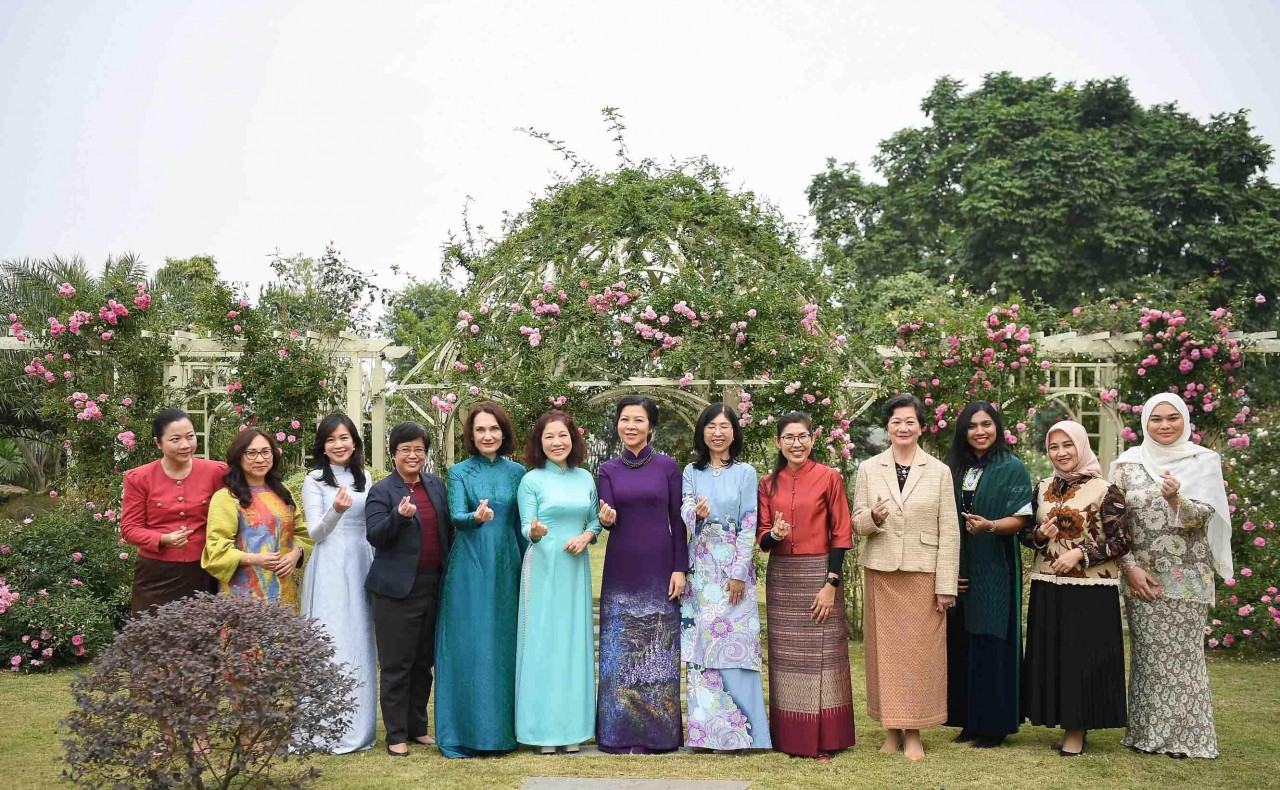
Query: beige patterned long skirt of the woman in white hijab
[{"left": 1124, "top": 597, "right": 1217, "bottom": 758}]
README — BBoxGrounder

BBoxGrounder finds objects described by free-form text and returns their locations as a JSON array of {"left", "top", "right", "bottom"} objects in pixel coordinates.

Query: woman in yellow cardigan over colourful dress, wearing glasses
[{"left": 200, "top": 428, "right": 311, "bottom": 607}]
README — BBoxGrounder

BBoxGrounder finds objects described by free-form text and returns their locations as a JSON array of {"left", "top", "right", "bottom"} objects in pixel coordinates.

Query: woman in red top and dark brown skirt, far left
[{"left": 120, "top": 408, "right": 227, "bottom": 615}]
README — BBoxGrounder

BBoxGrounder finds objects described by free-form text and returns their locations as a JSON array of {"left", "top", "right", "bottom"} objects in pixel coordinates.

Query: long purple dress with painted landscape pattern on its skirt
[{"left": 595, "top": 446, "right": 689, "bottom": 754}]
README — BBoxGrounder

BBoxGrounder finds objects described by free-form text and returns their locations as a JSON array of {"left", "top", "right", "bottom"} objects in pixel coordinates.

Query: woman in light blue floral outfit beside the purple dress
[{"left": 680, "top": 403, "right": 773, "bottom": 750}]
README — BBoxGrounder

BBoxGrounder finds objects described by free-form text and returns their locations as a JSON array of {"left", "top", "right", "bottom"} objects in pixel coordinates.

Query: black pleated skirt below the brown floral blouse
[{"left": 1023, "top": 580, "right": 1128, "bottom": 730}]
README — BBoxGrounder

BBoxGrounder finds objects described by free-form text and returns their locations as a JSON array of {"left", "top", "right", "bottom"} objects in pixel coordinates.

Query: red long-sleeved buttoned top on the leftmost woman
[{"left": 120, "top": 458, "right": 227, "bottom": 562}]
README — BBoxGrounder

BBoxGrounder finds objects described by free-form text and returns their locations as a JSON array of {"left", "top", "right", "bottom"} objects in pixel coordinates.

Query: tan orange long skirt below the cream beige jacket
[{"left": 863, "top": 568, "right": 947, "bottom": 730}]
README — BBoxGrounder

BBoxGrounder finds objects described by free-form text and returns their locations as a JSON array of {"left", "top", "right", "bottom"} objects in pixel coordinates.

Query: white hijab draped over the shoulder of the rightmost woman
[{"left": 1115, "top": 392, "right": 1235, "bottom": 579}]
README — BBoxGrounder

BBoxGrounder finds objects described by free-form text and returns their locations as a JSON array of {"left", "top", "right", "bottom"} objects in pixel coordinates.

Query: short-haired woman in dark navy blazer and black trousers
[{"left": 365, "top": 423, "right": 449, "bottom": 757}]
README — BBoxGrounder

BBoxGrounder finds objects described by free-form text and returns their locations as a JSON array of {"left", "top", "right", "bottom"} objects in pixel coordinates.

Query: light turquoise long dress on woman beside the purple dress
[{"left": 516, "top": 461, "right": 600, "bottom": 746}]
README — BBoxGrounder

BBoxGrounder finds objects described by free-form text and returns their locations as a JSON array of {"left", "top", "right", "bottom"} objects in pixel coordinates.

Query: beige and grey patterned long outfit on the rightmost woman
[{"left": 1115, "top": 464, "right": 1217, "bottom": 758}]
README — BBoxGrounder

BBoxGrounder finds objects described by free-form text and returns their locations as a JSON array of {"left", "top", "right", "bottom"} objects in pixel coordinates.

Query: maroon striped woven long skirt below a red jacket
[{"left": 765, "top": 554, "right": 855, "bottom": 757}]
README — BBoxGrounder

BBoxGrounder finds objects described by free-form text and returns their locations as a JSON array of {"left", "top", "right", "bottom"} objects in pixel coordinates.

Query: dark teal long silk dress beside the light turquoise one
[{"left": 435, "top": 455, "right": 527, "bottom": 757}]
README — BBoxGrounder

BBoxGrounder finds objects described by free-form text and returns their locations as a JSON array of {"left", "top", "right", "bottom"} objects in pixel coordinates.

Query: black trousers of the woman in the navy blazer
[{"left": 372, "top": 567, "right": 440, "bottom": 745}]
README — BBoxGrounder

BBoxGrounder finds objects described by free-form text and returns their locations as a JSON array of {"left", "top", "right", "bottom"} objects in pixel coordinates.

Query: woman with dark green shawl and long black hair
[{"left": 946, "top": 401, "right": 1032, "bottom": 749}]
